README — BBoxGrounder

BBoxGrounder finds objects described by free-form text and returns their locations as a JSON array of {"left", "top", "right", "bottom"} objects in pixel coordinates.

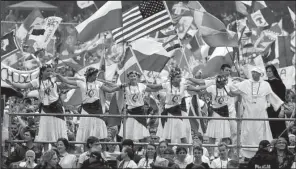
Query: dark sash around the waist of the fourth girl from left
[{"left": 161, "top": 98, "right": 187, "bottom": 127}]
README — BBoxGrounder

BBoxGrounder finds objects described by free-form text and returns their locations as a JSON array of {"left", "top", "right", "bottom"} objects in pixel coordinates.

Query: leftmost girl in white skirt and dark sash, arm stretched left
[{"left": 6, "top": 65, "right": 68, "bottom": 150}]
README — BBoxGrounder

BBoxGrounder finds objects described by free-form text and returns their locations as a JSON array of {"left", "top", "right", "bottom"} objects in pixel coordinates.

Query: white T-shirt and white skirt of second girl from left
[{"left": 76, "top": 79, "right": 108, "bottom": 142}]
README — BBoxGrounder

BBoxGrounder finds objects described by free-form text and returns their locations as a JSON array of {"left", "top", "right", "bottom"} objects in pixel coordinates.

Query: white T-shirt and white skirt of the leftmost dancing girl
[{"left": 31, "top": 78, "right": 68, "bottom": 142}]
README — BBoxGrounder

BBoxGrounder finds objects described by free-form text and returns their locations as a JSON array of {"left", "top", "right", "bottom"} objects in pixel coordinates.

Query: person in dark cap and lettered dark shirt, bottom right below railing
[{"left": 248, "top": 140, "right": 277, "bottom": 169}]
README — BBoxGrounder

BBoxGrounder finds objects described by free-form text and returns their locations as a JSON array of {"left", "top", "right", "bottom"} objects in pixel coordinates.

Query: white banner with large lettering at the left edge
[{"left": 1, "top": 63, "right": 39, "bottom": 83}]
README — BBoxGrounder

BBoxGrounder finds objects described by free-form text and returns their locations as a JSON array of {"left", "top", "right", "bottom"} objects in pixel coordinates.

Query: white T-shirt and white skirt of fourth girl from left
[{"left": 156, "top": 82, "right": 191, "bottom": 143}]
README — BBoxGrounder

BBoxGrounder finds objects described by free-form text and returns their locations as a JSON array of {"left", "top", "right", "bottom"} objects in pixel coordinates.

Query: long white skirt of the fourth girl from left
[{"left": 157, "top": 112, "right": 191, "bottom": 143}]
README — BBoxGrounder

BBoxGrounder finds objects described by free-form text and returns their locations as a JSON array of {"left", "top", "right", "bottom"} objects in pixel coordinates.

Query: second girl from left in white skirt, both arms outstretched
[{"left": 56, "top": 67, "right": 123, "bottom": 142}]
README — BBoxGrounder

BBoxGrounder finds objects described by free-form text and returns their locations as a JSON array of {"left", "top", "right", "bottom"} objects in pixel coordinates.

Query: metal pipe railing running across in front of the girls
[{"left": 4, "top": 96, "right": 295, "bottom": 160}]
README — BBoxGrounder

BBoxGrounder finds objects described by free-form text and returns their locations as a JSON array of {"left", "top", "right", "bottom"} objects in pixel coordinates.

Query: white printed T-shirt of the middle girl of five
[{"left": 125, "top": 83, "right": 146, "bottom": 109}]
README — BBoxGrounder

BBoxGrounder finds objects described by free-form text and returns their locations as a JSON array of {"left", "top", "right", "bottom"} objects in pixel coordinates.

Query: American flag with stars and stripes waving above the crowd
[{"left": 112, "top": 1, "right": 172, "bottom": 43}]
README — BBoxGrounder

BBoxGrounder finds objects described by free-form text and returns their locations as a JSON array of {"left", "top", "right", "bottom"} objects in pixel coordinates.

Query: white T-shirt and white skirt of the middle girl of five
[{"left": 119, "top": 83, "right": 150, "bottom": 140}]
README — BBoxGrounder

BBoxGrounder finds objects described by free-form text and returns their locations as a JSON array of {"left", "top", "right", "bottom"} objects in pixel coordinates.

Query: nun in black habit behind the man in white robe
[{"left": 265, "top": 65, "right": 288, "bottom": 139}]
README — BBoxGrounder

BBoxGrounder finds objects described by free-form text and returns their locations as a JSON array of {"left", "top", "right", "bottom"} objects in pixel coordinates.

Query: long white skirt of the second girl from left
[{"left": 76, "top": 108, "right": 108, "bottom": 142}]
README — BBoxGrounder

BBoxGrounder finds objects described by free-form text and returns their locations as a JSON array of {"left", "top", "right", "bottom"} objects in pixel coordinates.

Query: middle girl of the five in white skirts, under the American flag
[{"left": 119, "top": 71, "right": 150, "bottom": 140}]
